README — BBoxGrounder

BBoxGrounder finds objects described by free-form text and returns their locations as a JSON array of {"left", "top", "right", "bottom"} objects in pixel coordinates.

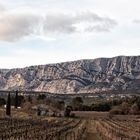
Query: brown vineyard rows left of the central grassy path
[{"left": 0, "top": 118, "right": 86, "bottom": 140}]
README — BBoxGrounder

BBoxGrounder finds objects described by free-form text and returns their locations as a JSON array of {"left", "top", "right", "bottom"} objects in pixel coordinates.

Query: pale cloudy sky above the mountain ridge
[{"left": 0, "top": 0, "right": 140, "bottom": 68}]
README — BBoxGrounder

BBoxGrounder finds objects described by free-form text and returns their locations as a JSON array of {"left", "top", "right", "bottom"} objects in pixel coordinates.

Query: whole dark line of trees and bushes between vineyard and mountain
[{"left": 0, "top": 91, "right": 140, "bottom": 116}]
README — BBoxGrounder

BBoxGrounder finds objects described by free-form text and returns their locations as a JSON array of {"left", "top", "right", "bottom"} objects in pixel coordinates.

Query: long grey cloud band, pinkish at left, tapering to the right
[{"left": 0, "top": 12, "right": 117, "bottom": 42}]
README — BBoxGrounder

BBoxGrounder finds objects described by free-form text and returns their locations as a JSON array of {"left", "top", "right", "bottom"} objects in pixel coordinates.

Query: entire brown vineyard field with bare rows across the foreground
[{"left": 0, "top": 118, "right": 140, "bottom": 140}]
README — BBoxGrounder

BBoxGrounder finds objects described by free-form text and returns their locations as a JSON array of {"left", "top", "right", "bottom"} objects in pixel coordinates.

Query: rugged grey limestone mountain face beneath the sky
[{"left": 0, "top": 56, "right": 140, "bottom": 93}]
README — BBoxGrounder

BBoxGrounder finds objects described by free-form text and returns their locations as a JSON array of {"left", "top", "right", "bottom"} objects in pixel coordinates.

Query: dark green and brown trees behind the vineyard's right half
[{"left": 70, "top": 96, "right": 140, "bottom": 115}]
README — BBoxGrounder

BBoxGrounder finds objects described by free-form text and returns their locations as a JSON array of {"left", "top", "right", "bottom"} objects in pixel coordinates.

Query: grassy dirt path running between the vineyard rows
[{"left": 87, "top": 121, "right": 101, "bottom": 140}]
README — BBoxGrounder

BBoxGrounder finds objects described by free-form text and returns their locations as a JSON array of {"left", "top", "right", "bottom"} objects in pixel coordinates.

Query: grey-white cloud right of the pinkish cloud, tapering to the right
[{"left": 44, "top": 12, "right": 117, "bottom": 33}]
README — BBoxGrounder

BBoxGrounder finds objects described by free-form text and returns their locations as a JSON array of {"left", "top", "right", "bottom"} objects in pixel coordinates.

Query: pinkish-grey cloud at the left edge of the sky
[{"left": 0, "top": 14, "right": 40, "bottom": 41}]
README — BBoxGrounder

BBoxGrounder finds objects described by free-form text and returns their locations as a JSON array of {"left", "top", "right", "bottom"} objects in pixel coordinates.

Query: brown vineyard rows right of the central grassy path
[{"left": 94, "top": 119, "right": 140, "bottom": 140}]
